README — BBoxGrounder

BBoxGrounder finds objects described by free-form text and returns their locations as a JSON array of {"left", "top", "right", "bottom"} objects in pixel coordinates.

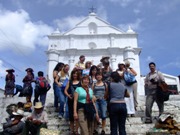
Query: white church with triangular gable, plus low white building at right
[{"left": 47, "top": 12, "right": 179, "bottom": 95}]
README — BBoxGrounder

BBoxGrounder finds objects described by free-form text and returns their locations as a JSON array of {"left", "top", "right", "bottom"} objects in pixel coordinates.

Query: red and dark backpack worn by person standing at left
[{"left": 37, "top": 77, "right": 49, "bottom": 90}]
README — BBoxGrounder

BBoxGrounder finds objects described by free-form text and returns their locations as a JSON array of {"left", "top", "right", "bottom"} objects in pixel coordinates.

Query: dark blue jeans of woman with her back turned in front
[{"left": 110, "top": 103, "right": 127, "bottom": 135}]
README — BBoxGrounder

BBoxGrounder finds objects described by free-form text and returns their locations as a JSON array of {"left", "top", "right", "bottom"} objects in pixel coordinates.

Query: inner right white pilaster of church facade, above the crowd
[{"left": 107, "top": 47, "right": 120, "bottom": 71}]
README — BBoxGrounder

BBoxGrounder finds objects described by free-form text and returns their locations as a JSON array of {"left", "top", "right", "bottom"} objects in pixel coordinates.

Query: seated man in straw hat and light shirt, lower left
[{"left": 23, "top": 102, "right": 48, "bottom": 135}]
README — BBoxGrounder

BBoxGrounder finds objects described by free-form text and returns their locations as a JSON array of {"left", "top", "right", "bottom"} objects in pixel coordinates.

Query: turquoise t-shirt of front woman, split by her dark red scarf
[{"left": 75, "top": 87, "right": 93, "bottom": 104}]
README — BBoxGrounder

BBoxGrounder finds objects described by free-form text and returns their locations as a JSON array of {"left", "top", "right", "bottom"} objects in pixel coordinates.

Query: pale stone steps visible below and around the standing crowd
[{"left": 46, "top": 95, "right": 180, "bottom": 135}]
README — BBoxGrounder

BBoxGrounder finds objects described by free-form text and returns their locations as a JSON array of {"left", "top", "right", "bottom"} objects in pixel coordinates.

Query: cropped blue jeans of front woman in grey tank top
[{"left": 96, "top": 99, "right": 107, "bottom": 120}]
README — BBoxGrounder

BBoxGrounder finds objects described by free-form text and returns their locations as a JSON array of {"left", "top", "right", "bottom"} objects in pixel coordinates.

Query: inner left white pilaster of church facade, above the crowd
[{"left": 66, "top": 48, "right": 77, "bottom": 71}]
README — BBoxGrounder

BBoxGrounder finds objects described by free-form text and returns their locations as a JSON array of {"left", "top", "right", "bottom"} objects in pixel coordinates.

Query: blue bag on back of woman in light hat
[{"left": 124, "top": 71, "right": 136, "bottom": 86}]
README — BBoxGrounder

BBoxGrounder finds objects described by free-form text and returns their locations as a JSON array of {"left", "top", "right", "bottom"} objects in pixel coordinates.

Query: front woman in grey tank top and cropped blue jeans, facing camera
[{"left": 92, "top": 72, "right": 108, "bottom": 135}]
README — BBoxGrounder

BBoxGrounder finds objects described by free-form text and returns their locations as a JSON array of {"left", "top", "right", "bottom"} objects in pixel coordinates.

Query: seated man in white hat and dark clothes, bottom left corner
[{"left": 0, "top": 109, "right": 25, "bottom": 135}]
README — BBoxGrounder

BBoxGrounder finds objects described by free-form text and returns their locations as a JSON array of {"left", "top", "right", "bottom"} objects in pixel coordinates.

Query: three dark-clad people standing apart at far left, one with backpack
[{"left": 4, "top": 68, "right": 51, "bottom": 105}]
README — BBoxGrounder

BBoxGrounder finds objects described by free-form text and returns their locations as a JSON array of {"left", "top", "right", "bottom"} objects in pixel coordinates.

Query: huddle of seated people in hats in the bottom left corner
[{"left": 0, "top": 102, "right": 48, "bottom": 135}]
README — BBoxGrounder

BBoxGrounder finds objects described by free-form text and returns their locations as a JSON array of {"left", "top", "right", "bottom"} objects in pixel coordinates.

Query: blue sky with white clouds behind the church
[{"left": 0, "top": 0, "right": 180, "bottom": 88}]
